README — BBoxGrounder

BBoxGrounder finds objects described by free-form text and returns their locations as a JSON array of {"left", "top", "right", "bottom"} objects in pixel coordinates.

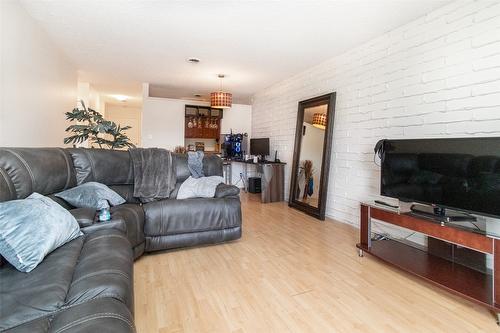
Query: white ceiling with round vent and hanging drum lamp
[{"left": 21, "top": 0, "right": 449, "bottom": 103}]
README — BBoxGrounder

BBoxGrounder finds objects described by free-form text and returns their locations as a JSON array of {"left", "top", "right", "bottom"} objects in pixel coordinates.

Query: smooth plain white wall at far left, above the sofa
[{"left": 0, "top": 0, "right": 77, "bottom": 147}]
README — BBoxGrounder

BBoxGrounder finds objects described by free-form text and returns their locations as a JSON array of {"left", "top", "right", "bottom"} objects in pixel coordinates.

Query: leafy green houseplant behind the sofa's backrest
[{"left": 64, "top": 101, "right": 135, "bottom": 149}]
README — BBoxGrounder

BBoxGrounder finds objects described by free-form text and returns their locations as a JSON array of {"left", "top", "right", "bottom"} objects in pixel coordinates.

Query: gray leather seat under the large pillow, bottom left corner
[{"left": 0, "top": 236, "right": 84, "bottom": 331}]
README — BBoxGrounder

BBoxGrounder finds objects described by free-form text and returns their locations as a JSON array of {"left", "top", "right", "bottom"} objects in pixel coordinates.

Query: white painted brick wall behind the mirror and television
[{"left": 252, "top": 1, "right": 500, "bottom": 225}]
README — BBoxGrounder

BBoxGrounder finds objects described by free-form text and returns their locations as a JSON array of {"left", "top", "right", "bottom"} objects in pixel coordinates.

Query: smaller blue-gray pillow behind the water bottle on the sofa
[{"left": 55, "top": 182, "right": 125, "bottom": 210}]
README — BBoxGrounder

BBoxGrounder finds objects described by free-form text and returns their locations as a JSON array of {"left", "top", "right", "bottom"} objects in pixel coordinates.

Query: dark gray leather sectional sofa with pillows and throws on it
[{"left": 0, "top": 148, "right": 241, "bottom": 333}]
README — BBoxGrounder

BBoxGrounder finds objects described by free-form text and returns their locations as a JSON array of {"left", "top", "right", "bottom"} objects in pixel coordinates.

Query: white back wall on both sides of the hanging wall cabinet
[{"left": 142, "top": 83, "right": 252, "bottom": 149}]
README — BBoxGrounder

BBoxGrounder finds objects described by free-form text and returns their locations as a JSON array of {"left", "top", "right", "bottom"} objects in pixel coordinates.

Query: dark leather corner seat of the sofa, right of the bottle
[{"left": 111, "top": 204, "right": 144, "bottom": 247}]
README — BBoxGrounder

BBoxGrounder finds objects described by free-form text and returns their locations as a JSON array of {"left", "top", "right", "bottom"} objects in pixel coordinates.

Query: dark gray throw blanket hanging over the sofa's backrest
[{"left": 129, "top": 148, "right": 176, "bottom": 203}]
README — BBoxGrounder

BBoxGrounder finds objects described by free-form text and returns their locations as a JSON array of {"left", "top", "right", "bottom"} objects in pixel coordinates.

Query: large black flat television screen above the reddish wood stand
[{"left": 381, "top": 137, "right": 500, "bottom": 217}]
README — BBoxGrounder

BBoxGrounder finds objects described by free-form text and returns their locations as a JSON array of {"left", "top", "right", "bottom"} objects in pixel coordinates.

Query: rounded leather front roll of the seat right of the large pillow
[{"left": 65, "top": 229, "right": 134, "bottom": 310}]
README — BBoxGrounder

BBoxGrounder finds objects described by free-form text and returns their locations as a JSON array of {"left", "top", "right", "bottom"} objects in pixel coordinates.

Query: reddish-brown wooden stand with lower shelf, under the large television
[{"left": 356, "top": 203, "right": 500, "bottom": 323}]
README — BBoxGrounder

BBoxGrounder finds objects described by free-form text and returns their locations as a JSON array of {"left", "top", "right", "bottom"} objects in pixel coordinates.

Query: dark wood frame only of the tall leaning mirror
[{"left": 288, "top": 92, "right": 336, "bottom": 220}]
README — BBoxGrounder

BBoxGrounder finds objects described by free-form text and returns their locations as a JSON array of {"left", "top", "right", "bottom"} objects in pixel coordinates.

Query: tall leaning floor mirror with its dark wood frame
[{"left": 288, "top": 92, "right": 335, "bottom": 220}]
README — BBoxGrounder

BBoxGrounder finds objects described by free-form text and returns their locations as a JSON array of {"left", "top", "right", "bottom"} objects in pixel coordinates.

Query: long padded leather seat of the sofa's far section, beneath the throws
[{"left": 143, "top": 197, "right": 241, "bottom": 236}]
